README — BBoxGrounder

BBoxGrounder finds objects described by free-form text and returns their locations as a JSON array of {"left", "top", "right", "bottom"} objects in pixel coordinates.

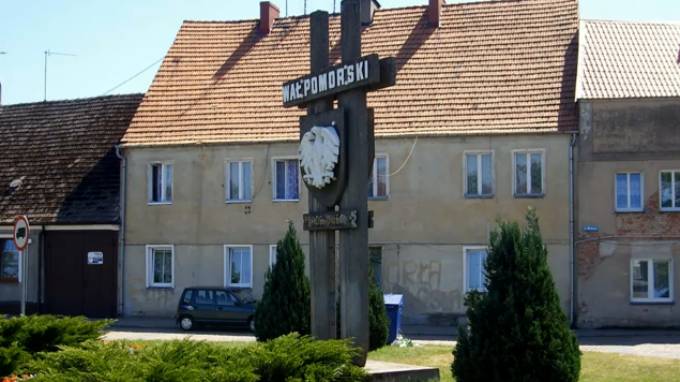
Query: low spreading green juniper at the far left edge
[{"left": 0, "top": 315, "right": 111, "bottom": 376}]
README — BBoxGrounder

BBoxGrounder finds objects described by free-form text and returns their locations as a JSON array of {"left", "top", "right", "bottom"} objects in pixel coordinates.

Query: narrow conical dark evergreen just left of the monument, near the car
[{"left": 255, "top": 223, "right": 311, "bottom": 341}]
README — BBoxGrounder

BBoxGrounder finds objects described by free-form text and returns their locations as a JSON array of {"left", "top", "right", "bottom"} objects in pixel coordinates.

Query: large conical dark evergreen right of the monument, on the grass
[{"left": 452, "top": 210, "right": 581, "bottom": 382}]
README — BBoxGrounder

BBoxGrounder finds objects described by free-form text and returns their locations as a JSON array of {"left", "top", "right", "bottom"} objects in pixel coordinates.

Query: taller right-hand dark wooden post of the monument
[{"left": 338, "top": 0, "right": 370, "bottom": 366}]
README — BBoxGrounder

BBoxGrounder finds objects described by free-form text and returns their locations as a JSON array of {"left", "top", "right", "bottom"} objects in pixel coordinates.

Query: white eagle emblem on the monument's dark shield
[{"left": 300, "top": 126, "right": 340, "bottom": 189}]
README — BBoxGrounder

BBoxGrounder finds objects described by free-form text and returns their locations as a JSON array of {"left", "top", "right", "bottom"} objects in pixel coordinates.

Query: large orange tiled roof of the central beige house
[{"left": 124, "top": 0, "right": 578, "bottom": 146}]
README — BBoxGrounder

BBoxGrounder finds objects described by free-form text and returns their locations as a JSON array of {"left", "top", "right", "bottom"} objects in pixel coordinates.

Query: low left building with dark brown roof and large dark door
[{"left": 0, "top": 94, "right": 142, "bottom": 317}]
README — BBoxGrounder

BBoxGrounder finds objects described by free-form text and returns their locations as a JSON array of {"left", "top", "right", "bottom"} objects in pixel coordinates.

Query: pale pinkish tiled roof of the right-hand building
[{"left": 577, "top": 20, "right": 680, "bottom": 99}]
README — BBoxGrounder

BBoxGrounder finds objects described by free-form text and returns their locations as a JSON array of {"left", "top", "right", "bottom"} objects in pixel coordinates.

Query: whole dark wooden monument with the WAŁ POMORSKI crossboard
[{"left": 282, "top": 0, "right": 396, "bottom": 365}]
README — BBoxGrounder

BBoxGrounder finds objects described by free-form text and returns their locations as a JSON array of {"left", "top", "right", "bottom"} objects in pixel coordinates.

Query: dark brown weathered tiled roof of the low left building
[{"left": 0, "top": 94, "right": 142, "bottom": 224}]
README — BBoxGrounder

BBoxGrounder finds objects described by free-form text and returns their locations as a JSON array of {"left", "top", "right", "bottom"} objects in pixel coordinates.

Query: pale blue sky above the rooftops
[{"left": 0, "top": 0, "right": 680, "bottom": 104}]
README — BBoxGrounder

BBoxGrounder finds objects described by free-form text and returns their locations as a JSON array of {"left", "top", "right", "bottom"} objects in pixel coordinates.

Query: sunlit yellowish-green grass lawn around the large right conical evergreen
[{"left": 369, "top": 346, "right": 680, "bottom": 382}]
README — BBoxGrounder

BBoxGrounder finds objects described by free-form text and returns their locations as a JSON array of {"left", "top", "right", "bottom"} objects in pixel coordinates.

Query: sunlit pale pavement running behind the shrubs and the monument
[{"left": 104, "top": 327, "right": 680, "bottom": 360}]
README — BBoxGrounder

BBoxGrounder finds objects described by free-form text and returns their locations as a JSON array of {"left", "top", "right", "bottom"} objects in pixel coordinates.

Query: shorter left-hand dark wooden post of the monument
[{"left": 307, "top": 11, "right": 338, "bottom": 339}]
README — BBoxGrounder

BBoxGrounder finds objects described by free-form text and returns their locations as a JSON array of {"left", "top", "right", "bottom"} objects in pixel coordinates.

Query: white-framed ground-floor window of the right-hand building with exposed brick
[{"left": 630, "top": 259, "right": 673, "bottom": 302}]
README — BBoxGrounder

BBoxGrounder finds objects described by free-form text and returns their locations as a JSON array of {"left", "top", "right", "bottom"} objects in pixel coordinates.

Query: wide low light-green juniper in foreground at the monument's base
[{"left": 30, "top": 334, "right": 366, "bottom": 382}]
